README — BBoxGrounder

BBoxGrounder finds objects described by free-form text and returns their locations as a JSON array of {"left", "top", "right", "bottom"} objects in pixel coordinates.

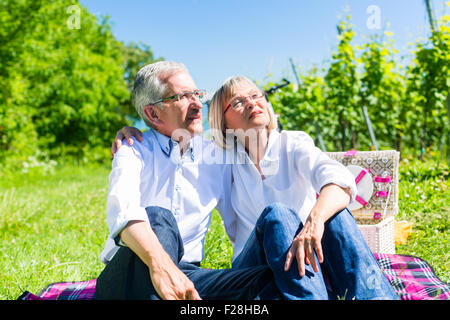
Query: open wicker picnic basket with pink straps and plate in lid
[{"left": 326, "top": 150, "right": 400, "bottom": 254}]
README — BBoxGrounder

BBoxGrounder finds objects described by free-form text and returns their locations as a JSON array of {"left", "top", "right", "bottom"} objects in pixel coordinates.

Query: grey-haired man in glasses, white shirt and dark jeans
[{"left": 95, "top": 61, "right": 276, "bottom": 299}]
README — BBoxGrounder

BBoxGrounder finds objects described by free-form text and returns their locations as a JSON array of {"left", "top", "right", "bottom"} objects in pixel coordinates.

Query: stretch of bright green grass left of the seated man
[{"left": 0, "top": 166, "right": 108, "bottom": 299}]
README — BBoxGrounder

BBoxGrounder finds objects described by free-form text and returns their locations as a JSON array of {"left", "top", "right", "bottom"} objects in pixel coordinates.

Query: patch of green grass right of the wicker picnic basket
[{"left": 396, "top": 156, "right": 450, "bottom": 283}]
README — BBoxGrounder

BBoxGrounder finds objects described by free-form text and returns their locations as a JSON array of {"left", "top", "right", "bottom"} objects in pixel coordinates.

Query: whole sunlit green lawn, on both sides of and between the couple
[{"left": 0, "top": 156, "right": 450, "bottom": 299}]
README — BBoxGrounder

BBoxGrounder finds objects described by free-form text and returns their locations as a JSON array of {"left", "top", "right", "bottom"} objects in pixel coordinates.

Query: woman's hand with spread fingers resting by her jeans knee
[{"left": 284, "top": 212, "right": 325, "bottom": 277}]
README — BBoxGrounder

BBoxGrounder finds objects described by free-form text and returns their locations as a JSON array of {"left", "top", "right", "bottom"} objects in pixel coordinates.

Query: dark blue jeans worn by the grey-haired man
[{"left": 95, "top": 207, "right": 278, "bottom": 300}]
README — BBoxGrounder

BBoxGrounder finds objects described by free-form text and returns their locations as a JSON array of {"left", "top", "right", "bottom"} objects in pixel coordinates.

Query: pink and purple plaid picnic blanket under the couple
[{"left": 18, "top": 253, "right": 450, "bottom": 300}]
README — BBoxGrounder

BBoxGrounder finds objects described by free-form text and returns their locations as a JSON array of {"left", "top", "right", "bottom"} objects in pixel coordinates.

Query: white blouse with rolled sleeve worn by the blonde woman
[{"left": 227, "top": 130, "right": 357, "bottom": 259}]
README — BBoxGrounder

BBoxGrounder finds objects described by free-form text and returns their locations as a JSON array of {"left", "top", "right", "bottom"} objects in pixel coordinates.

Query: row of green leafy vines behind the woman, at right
[{"left": 268, "top": 7, "right": 450, "bottom": 157}]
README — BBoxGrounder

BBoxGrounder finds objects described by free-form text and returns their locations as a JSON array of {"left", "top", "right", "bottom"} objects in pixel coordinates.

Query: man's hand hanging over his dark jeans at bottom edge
[{"left": 149, "top": 254, "right": 201, "bottom": 300}]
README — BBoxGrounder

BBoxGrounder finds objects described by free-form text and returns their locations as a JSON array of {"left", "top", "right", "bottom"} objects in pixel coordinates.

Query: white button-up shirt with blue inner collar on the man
[{"left": 100, "top": 129, "right": 235, "bottom": 263}]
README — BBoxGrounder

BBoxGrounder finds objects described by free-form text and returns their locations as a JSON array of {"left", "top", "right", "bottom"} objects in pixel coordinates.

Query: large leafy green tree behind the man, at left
[{"left": 0, "top": 0, "right": 161, "bottom": 167}]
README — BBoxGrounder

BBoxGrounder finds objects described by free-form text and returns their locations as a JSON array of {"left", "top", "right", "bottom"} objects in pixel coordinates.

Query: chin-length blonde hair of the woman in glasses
[{"left": 209, "top": 76, "right": 278, "bottom": 149}]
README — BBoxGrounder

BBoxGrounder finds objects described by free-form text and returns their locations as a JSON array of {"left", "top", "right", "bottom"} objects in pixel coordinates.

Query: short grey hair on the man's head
[{"left": 133, "top": 61, "right": 188, "bottom": 127}]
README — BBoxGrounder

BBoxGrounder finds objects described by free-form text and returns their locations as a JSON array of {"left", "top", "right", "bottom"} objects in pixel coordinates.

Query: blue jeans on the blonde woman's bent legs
[{"left": 233, "top": 204, "right": 398, "bottom": 300}]
